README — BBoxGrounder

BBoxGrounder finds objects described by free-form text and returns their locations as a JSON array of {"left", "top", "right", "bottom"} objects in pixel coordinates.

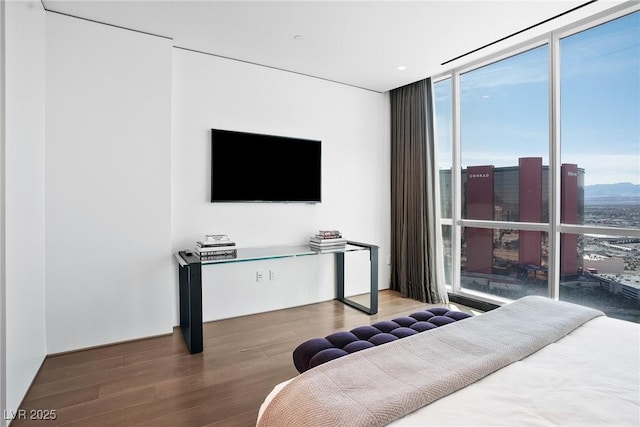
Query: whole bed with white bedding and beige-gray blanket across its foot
[{"left": 257, "top": 296, "right": 640, "bottom": 427}]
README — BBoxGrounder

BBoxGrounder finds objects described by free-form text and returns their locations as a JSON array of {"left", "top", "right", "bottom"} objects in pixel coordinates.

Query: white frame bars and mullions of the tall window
[{"left": 431, "top": 3, "right": 640, "bottom": 304}]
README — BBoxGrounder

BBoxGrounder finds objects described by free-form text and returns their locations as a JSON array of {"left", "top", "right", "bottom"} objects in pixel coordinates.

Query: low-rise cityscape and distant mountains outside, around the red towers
[{"left": 461, "top": 184, "right": 640, "bottom": 323}]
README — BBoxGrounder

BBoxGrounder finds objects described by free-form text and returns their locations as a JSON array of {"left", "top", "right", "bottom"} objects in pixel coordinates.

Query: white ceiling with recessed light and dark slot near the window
[{"left": 42, "top": 0, "right": 621, "bottom": 92}]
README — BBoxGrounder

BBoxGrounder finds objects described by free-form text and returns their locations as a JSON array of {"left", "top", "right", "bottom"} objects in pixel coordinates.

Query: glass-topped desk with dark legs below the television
[{"left": 175, "top": 241, "right": 378, "bottom": 354}]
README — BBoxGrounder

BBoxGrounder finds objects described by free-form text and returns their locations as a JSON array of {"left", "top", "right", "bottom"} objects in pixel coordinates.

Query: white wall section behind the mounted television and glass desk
[{"left": 172, "top": 49, "right": 390, "bottom": 321}]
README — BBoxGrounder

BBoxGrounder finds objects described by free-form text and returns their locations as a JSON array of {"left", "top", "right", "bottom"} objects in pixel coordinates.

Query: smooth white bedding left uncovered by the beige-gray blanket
[{"left": 258, "top": 317, "right": 640, "bottom": 427}]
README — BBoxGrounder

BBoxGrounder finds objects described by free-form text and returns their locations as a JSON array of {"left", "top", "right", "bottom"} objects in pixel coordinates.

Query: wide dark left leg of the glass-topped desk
[{"left": 178, "top": 254, "right": 203, "bottom": 354}]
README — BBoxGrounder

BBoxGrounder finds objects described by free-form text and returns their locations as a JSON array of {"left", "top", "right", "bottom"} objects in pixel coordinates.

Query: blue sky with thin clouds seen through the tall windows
[{"left": 434, "top": 12, "right": 640, "bottom": 185}]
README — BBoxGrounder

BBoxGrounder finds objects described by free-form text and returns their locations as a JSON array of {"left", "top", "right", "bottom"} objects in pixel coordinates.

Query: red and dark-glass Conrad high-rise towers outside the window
[{"left": 440, "top": 157, "right": 585, "bottom": 276}]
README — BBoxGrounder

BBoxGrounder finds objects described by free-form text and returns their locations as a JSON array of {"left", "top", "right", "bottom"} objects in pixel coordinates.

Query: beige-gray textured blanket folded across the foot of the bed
[{"left": 258, "top": 296, "right": 603, "bottom": 427}]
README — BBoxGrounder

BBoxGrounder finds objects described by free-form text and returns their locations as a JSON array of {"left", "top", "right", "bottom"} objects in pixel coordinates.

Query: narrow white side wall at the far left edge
[{"left": 2, "top": 1, "right": 46, "bottom": 415}]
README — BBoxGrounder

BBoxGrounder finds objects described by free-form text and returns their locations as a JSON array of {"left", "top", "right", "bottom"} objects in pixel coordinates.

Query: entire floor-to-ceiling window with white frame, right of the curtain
[{"left": 433, "top": 5, "right": 640, "bottom": 322}]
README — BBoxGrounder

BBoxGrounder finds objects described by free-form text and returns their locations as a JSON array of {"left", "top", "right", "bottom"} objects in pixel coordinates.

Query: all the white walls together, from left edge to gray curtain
[{"left": 0, "top": 5, "right": 389, "bottom": 425}]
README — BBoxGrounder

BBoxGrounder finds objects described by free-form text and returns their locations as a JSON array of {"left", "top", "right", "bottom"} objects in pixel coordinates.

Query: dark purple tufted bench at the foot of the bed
[{"left": 293, "top": 307, "right": 471, "bottom": 373}]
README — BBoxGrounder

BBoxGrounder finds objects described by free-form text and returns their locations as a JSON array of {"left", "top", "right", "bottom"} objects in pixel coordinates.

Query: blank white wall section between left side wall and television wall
[{"left": 46, "top": 13, "right": 175, "bottom": 354}]
